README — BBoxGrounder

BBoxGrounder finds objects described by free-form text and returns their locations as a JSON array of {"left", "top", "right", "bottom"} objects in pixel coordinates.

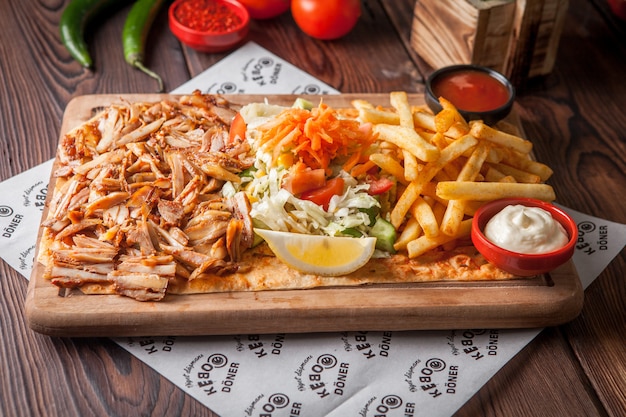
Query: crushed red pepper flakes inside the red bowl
[{"left": 174, "top": 0, "right": 242, "bottom": 33}]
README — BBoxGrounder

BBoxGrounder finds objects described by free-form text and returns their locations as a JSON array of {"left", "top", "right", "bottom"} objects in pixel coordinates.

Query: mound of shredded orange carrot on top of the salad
[{"left": 258, "top": 103, "right": 375, "bottom": 169}]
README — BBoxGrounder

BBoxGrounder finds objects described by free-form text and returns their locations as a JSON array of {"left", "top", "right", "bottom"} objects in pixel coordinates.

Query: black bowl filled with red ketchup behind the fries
[{"left": 425, "top": 64, "right": 515, "bottom": 125}]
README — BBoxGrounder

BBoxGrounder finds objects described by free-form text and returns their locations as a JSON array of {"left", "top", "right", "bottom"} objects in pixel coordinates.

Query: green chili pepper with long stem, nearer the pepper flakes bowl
[{"left": 122, "top": 0, "right": 164, "bottom": 92}]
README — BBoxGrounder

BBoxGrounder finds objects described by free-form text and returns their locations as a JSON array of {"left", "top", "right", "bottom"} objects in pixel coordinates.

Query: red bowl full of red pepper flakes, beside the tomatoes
[{"left": 168, "top": 0, "right": 250, "bottom": 52}]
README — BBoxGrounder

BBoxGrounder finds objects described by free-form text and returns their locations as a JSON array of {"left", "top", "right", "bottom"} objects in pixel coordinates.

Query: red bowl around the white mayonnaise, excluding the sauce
[{"left": 471, "top": 198, "right": 578, "bottom": 277}]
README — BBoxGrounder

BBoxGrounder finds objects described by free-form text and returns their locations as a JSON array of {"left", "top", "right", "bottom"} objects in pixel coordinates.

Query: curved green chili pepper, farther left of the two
[{"left": 59, "top": 0, "right": 122, "bottom": 68}]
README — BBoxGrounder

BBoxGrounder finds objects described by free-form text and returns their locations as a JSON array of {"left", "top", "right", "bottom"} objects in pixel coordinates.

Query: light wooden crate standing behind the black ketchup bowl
[{"left": 411, "top": 0, "right": 569, "bottom": 87}]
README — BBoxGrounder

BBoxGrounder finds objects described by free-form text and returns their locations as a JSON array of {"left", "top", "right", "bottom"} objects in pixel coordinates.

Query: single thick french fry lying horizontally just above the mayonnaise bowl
[{"left": 437, "top": 181, "right": 556, "bottom": 201}]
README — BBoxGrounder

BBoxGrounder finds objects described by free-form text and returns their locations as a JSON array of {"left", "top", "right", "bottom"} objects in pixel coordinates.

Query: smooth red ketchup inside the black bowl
[{"left": 432, "top": 69, "right": 509, "bottom": 112}]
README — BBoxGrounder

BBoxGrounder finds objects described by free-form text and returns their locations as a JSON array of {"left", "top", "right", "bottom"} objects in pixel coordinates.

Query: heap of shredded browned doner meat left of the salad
[{"left": 39, "top": 92, "right": 253, "bottom": 301}]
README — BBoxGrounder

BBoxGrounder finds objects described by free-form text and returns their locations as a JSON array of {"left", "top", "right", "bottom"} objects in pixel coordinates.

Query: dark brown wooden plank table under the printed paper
[{"left": 0, "top": 0, "right": 626, "bottom": 416}]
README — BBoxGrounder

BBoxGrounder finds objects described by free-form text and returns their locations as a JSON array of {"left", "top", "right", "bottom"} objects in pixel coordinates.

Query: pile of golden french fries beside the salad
[{"left": 352, "top": 92, "right": 556, "bottom": 258}]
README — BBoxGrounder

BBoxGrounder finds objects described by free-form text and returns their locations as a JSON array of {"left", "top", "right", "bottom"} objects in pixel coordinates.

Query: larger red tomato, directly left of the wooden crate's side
[{"left": 291, "top": 0, "right": 361, "bottom": 40}]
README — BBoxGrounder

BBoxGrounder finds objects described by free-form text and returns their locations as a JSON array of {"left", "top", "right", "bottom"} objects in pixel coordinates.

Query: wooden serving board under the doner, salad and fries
[{"left": 26, "top": 94, "right": 583, "bottom": 337}]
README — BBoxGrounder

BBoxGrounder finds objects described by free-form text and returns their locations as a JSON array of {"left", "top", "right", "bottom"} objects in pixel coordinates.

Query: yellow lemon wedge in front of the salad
[{"left": 254, "top": 229, "right": 376, "bottom": 276}]
